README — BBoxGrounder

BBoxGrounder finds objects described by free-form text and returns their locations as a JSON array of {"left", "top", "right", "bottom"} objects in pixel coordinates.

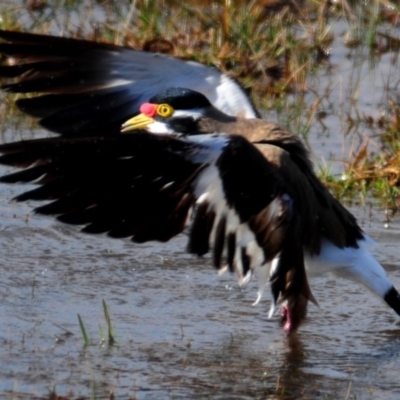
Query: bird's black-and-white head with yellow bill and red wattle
[{"left": 121, "top": 87, "right": 235, "bottom": 134}]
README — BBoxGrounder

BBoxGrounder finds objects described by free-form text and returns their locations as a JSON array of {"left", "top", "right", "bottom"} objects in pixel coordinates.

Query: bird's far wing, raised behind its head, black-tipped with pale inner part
[{"left": 0, "top": 31, "right": 257, "bottom": 136}]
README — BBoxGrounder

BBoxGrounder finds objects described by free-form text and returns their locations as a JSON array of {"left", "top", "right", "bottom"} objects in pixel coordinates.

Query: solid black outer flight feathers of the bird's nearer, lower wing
[{"left": 0, "top": 134, "right": 202, "bottom": 242}]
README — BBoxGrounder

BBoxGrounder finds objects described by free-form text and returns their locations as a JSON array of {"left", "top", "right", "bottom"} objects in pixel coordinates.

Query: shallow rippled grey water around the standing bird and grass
[{"left": 0, "top": 13, "right": 400, "bottom": 399}]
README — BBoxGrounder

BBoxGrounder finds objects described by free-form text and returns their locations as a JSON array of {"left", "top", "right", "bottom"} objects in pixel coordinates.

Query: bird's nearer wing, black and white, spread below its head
[{"left": 0, "top": 133, "right": 308, "bottom": 310}]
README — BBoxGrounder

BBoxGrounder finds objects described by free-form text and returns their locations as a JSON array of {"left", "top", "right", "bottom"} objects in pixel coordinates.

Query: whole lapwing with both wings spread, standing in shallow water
[{"left": 0, "top": 31, "right": 400, "bottom": 332}]
